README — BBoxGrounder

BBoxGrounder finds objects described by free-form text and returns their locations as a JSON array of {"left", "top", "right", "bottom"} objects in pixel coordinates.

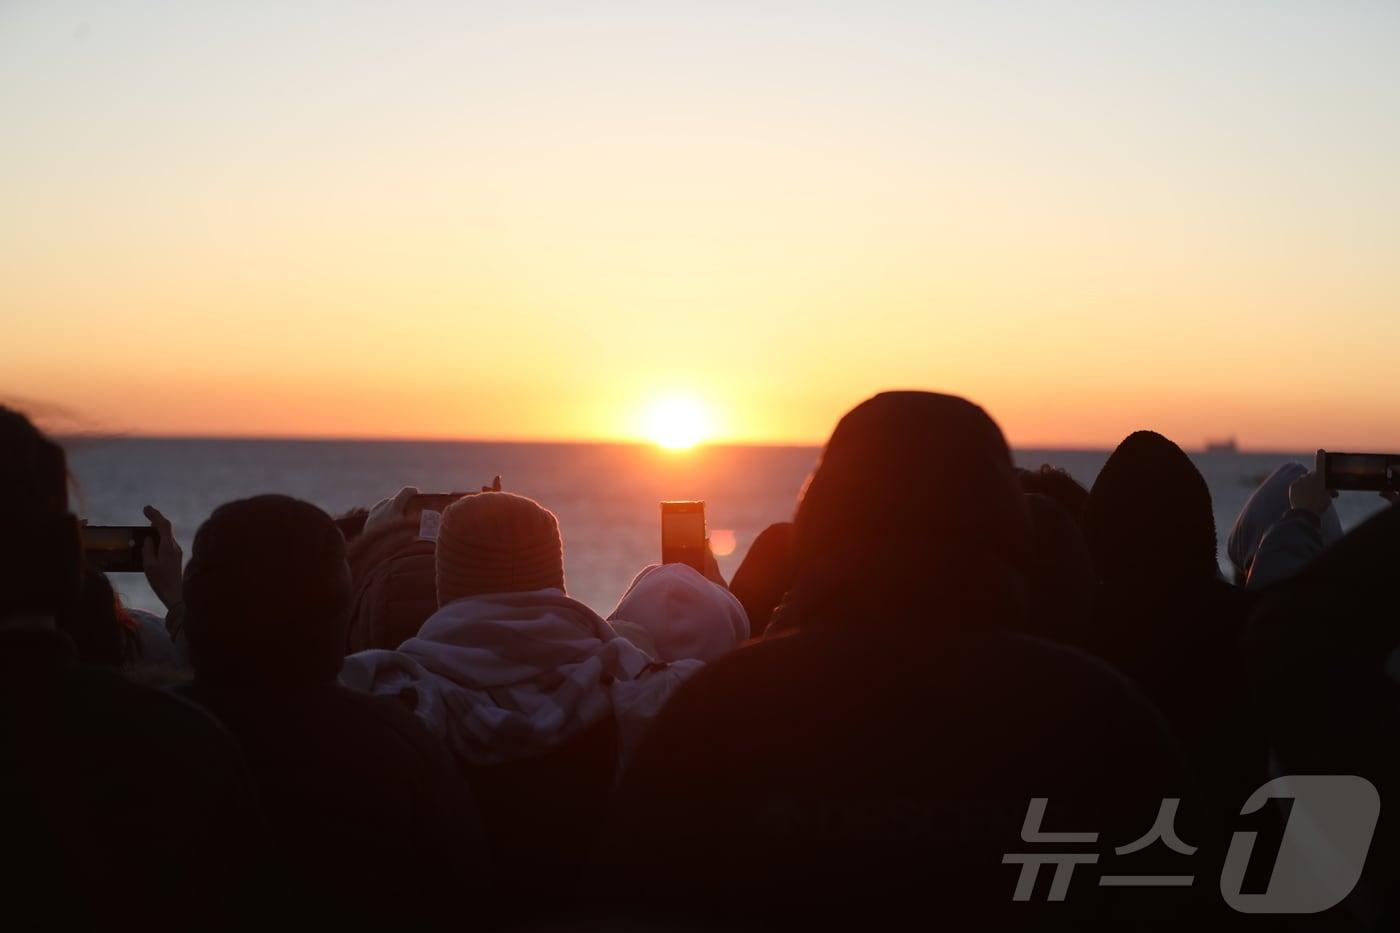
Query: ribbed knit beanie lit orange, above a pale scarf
[{"left": 437, "top": 492, "right": 564, "bottom": 605}]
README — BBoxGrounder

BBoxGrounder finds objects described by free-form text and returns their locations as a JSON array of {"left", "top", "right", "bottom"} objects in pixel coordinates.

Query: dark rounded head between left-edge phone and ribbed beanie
[{"left": 185, "top": 496, "right": 350, "bottom": 685}]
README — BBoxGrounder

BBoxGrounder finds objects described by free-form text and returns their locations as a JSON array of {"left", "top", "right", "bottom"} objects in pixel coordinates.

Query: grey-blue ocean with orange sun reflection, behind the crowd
[{"left": 67, "top": 437, "right": 1385, "bottom": 615}]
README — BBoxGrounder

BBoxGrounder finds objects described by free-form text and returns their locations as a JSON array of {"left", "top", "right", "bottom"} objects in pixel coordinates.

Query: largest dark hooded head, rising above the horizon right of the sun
[{"left": 784, "top": 392, "right": 1030, "bottom": 626}]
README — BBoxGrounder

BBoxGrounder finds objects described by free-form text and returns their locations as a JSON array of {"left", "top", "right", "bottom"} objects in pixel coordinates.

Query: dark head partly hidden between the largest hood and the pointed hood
[{"left": 1025, "top": 493, "right": 1098, "bottom": 644}]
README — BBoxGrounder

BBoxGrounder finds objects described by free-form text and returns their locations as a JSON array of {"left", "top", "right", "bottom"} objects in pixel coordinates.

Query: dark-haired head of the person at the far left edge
[{"left": 0, "top": 405, "right": 83, "bottom": 618}]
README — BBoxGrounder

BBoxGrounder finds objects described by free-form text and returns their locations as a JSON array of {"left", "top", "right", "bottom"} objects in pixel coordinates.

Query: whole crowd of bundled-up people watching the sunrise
[{"left": 0, "top": 392, "right": 1400, "bottom": 930}]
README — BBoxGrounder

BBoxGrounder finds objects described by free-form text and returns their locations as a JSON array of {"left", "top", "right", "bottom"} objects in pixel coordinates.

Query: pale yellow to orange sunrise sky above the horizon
[{"left": 0, "top": 0, "right": 1400, "bottom": 450}]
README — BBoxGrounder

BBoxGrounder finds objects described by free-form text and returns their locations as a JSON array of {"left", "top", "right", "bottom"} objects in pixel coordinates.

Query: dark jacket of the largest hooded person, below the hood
[{"left": 589, "top": 626, "right": 1203, "bottom": 929}]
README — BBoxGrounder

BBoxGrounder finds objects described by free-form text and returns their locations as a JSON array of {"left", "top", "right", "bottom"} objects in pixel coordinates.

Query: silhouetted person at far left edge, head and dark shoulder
[{"left": 0, "top": 406, "right": 269, "bottom": 930}]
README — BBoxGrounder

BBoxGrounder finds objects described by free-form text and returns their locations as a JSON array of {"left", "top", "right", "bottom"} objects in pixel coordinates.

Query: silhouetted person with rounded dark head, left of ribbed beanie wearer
[{"left": 183, "top": 496, "right": 484, "bottom": 923}]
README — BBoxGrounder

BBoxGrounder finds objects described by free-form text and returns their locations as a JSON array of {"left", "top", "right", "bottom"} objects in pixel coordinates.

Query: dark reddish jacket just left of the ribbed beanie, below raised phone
[{"left": 346, "top": 518, "right": 437, "bottom": 654}]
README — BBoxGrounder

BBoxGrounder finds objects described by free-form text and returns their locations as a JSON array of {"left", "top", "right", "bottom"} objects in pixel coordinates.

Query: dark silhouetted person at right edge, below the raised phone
[{"left": 1247, "top": 509, "right": 1400, "bottom": 930}]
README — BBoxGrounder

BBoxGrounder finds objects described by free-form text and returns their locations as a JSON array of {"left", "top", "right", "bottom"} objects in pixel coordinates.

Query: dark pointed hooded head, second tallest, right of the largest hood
[{"left": 1084, "top": 431, "right": 1219, "bottom": 586}]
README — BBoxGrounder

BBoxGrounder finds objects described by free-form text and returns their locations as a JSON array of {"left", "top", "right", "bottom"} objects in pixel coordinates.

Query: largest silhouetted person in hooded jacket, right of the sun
[{"left": 587, "top": 392, "right": 1190, "bottom": 929}]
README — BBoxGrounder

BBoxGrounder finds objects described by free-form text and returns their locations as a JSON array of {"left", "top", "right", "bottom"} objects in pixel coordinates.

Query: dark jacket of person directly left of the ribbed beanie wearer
[{"left": 186, "top": 682, "right": 486, "bottom": 923}]
